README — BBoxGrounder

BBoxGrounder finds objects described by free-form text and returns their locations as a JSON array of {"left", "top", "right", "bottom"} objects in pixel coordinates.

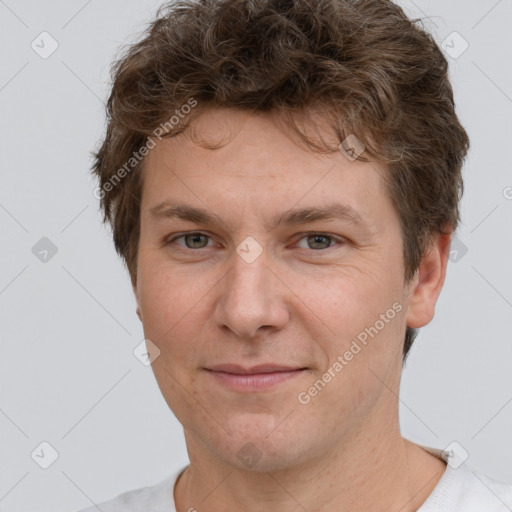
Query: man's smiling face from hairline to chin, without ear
[{"left": 135, "top": 110, "right": 422, "bottom": 470}]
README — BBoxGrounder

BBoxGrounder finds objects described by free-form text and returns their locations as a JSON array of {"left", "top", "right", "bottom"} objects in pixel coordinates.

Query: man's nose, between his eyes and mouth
[{"left": 214, "top": 245, "right": 290, "bottom": 339}]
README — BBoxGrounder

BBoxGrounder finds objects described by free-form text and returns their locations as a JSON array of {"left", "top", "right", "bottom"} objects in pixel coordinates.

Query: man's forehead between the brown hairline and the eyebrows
[{"left": 142, "top": 109, "right": 387, "bottom": 223}]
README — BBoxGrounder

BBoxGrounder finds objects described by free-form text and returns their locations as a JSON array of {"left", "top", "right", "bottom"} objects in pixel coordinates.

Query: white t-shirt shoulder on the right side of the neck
[{"left": 419, "top": 465, "right": 512, "bottom": 512}]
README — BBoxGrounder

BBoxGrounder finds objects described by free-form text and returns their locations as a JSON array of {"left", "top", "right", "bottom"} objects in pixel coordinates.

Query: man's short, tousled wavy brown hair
[{"left": 92, "top": 0, "right": 469, "bottom": 358}]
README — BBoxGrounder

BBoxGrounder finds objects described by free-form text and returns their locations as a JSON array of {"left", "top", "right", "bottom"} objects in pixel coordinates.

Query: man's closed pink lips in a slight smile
[{"left": 205, "top": 364, "right": 307, "bottom": 393}]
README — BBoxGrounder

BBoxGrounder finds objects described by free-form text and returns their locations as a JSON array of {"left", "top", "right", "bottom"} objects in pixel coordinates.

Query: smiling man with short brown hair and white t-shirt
[{"left": 81, "top": 0, "right": 512, "bottom": 512}]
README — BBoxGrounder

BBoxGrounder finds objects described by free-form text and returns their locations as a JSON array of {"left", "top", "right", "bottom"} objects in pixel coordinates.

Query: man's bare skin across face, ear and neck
[{"left": 132, "top": 109, "right": 450, "bottom": 512}]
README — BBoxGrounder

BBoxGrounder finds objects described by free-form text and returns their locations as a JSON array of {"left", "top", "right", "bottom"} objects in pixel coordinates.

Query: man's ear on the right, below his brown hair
[{"left": 406, "top": 233, "right": 451, "bottom": 328}]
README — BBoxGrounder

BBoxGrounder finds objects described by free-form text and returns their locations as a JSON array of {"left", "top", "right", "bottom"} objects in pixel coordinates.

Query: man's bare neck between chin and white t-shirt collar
[{"left": 175, "top": 428, "right": 446, "bottom": 512}]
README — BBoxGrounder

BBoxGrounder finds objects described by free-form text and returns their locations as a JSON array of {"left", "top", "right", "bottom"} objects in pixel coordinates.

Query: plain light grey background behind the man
[{"left": 0, "top": 0, "right": 512, "bottom": 512}]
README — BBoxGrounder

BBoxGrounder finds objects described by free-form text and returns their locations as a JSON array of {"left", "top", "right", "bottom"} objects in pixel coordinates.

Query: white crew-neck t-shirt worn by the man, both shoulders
[{"left": 79, "top": 447, "right": 512, "bottom": 512}]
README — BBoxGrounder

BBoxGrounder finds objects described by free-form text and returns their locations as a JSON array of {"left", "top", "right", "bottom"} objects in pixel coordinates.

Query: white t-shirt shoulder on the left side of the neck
[{"left": 72, "top": 468, "right": 184, "bottom": 512}]
